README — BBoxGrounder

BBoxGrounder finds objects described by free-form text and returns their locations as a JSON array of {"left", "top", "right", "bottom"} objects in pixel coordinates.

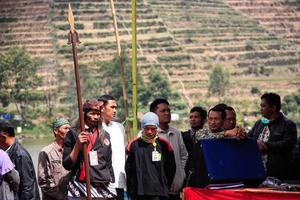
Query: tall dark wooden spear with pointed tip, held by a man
[{"left": 68, "top": 4, "right": 92, "bottom": 200}]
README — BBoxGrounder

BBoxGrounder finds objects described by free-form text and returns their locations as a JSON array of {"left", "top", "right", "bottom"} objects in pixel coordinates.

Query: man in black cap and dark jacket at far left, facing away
[{"left": 0, "top": 123, "right": 40, "bottom": 200}]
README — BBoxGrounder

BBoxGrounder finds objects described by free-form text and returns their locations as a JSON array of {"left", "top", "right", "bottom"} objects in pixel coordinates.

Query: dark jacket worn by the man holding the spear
[{"left": 63, "top": 128, "right": 114, "bottom": 185}]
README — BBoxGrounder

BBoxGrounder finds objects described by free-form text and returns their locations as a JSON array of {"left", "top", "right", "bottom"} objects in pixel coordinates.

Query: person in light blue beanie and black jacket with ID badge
[{"left": 125, "top": 112, "right": 176, "bottom": 200}]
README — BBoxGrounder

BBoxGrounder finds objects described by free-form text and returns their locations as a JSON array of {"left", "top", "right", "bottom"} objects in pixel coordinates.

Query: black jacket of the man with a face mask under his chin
[{"left": 248, "top": 113, "right": 297, "bottom": 180}]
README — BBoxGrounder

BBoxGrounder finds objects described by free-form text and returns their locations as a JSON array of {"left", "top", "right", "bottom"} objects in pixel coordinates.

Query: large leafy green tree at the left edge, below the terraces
[{"left": 0, "top": 47, "right": 43, "bottom": 120}]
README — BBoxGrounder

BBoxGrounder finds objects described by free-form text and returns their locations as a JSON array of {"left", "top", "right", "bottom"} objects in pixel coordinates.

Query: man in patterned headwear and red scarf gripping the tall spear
[{"left": 63, "top": 100, "right": 116, "bottom": 200}]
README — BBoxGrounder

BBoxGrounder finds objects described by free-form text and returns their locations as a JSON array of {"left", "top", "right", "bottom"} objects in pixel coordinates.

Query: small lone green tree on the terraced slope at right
[{"left": 208, "top": 65, "right": 229, "bottom": 96}]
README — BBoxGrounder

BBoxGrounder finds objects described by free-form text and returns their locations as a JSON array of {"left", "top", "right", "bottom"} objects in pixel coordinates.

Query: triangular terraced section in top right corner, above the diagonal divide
[{"left": 226, "top": 0, "right": 300, "bottom": 44}]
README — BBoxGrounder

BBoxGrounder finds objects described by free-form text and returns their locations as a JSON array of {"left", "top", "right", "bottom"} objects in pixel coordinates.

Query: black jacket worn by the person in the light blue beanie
[{"left": 125, "top": 138, "right": 176, "bottom": 197}]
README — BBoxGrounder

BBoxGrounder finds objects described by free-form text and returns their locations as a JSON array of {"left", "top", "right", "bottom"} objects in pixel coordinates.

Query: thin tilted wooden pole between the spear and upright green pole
[{"left": 110, "top": 0, "right": 131, "bottom": 139}]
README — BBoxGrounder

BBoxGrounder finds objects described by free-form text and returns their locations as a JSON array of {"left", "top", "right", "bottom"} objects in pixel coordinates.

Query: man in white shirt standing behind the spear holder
[{"left": 98, "top": 95, "right": 126, "bottom": 200}]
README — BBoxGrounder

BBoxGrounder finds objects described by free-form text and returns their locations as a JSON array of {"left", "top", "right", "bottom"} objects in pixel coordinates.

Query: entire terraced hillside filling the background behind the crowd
[{"left": 0, "top": 0, "right": 300, "bottom": 119}]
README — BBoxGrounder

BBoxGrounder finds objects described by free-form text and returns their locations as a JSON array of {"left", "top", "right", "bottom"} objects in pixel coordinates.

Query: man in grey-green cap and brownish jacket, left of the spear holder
[{"left": 38, "top": 118, "right": 70, "bottom": 200}]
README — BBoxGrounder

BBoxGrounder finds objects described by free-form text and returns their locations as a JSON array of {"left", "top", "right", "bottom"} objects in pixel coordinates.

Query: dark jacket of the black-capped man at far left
[{"left": 7, "top": 141, "right": 40, "bottom": 200}]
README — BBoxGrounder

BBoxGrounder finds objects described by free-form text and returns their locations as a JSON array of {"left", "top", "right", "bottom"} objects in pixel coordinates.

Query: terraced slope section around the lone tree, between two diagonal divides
[{"left": 148, "top": 0, "right": 300, "bottom": 112}]
